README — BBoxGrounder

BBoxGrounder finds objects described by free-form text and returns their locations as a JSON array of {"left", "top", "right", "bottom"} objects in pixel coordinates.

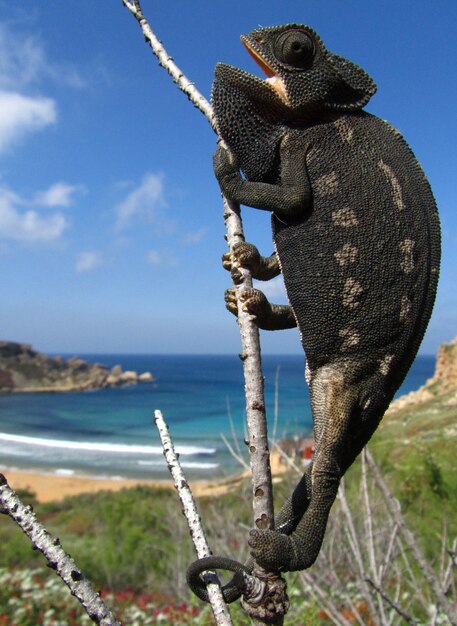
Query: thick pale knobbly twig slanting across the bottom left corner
[{"left": 0, "top": 474, "right": 121, "bottom": 626}]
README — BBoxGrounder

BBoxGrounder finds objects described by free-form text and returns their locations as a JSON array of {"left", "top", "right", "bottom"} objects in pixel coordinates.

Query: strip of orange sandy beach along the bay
[{"left": 0, "top": 468, "right": 248, "bottom": 502}]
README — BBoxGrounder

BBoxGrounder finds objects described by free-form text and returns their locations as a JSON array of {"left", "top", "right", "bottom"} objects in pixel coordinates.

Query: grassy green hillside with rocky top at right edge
[{"left": 369, "top": 338, "right": 457, "bottom": 545}]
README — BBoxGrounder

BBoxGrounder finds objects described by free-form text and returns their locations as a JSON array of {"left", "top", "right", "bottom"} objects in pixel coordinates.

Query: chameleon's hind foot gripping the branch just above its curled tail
[{"left": 248, "top": 529, "right": 294, "bottom": 572}]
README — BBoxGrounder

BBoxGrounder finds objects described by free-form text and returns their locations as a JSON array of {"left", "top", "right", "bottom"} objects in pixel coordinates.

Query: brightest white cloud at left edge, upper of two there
[{"left": 0, "top": 91, "right": 57, "bottom": 153}]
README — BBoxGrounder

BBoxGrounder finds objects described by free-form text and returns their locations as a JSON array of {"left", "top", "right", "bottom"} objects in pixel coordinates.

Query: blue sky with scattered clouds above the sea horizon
[{"left": 0, "top": 0, "right": 457, "bottom": 354}]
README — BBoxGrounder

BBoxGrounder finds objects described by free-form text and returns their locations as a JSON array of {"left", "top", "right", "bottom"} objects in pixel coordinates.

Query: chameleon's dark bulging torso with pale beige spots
[{"left": 273, "top": 116, "right": 440, "bottom": 386}]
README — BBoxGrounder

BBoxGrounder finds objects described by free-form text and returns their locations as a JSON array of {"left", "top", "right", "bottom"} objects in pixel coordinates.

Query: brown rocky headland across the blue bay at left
[{"left": 0, "top": 341, "right": 154, "bottom": 393}]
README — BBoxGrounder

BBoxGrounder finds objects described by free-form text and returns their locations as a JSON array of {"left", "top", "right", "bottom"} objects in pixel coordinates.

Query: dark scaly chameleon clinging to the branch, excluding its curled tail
[{"left": 213, "top": 24, "right": 440, "bottom": 571}]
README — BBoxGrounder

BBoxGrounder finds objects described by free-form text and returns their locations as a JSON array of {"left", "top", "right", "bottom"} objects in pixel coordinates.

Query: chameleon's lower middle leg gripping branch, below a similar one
[{"left": 225, "top": 289, "right": 297, "bottom": 330}]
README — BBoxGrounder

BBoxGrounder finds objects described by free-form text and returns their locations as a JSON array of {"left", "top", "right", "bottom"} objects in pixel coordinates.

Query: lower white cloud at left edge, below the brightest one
[{"left": 0, "top": 188, "right": 69, "bottom": 243}]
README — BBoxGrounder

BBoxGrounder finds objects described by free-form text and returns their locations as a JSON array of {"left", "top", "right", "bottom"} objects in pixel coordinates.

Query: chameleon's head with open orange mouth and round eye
[{"left": 212, "top": 24, "right": 376, "bottom": 123}]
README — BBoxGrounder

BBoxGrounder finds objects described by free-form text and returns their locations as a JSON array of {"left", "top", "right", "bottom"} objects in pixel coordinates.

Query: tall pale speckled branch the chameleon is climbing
[{"left": 122, "top": 0, "right": 285, "bottom": 623}]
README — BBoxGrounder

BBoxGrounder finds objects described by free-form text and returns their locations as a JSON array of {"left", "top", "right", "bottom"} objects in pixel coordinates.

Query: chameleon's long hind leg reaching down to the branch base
[{"left": 249, "top": 372, "right": 356, "bottom": 571}]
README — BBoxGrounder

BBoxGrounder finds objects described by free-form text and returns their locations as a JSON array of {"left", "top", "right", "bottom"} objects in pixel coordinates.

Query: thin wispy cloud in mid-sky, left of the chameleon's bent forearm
[{"left": 115, "top": 174, "right": 167, "bottom": 231}]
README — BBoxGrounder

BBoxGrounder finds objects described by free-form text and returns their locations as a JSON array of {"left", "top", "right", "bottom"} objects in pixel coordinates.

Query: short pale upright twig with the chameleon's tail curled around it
[{"left": 154, "top": 411, "right": 232, "bottom": 626}]
